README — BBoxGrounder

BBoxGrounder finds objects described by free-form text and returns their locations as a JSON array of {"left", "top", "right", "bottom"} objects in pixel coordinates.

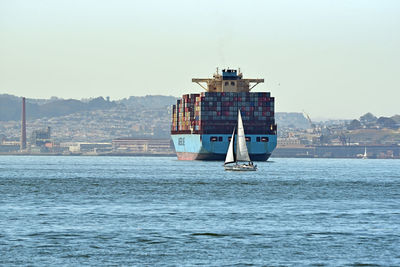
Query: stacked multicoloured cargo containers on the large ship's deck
[{"left": 171, "top": 92, "right": 276, "bottom": 134}]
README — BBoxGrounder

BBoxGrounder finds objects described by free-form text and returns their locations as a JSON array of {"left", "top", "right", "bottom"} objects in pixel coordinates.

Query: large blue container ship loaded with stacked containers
[{"left": 171, "top": 69, "right": 277, "bottom": 161}]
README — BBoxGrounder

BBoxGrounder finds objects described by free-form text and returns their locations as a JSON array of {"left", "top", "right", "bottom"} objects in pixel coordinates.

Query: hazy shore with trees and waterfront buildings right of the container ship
[{"left": 273, "top": 113, "right": 400, "bottom": 158}]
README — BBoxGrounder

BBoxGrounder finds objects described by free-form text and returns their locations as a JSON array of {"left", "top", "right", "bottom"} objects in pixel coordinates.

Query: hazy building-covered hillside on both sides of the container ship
[{"left": 0, "top": 95, "right": 400, "bottom": 157}]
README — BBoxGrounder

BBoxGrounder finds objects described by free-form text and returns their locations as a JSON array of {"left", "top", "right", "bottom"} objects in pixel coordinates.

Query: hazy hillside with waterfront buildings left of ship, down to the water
[{"left": 0, "top": 95, "right": 176, "bottom": 154}]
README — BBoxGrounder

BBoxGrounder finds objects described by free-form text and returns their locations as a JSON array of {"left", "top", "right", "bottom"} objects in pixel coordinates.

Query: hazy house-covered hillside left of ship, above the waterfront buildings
[{"left": 0, "top": 96, "right": 175, "bottom": 142}]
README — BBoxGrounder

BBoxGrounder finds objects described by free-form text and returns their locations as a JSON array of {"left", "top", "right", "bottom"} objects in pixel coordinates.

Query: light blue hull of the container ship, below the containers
[{"left": 171, "top": 134, "right": 277, "bottom": 161}]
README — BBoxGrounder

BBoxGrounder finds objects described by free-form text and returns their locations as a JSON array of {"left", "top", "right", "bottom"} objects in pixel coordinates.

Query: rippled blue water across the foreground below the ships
[{"left": 0, "top": 156, "right": 400, "bottom": 266}]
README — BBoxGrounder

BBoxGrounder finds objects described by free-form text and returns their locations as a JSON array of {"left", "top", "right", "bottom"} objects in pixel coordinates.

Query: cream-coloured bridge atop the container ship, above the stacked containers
[{"left": 192, "top": 68, "right": 264, "bottom": 92}]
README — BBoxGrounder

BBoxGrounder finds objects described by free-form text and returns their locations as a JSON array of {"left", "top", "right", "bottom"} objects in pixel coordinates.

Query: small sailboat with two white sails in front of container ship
[{"left": 224, "top": 110, "right": 257, "bottom": 171}]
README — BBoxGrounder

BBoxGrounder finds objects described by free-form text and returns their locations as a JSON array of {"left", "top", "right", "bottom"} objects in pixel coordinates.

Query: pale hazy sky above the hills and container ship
[{"left": 0, "top": 0, "right": 400, "bottom": 118}]
